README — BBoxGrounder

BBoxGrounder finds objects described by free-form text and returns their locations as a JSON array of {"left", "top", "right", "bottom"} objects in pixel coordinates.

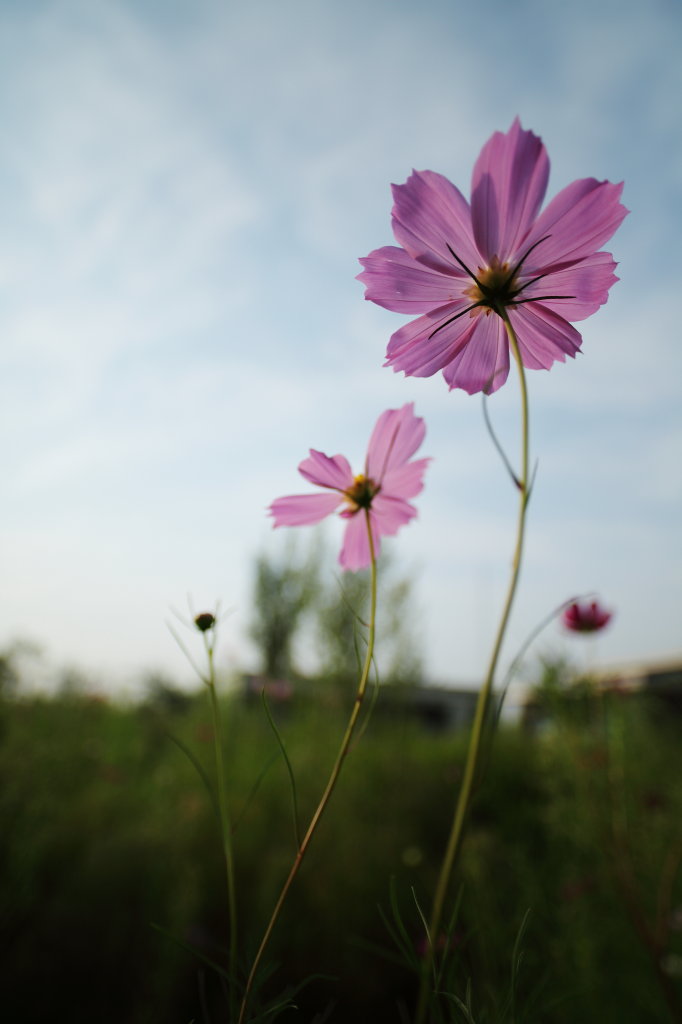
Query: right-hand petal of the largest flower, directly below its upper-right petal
[{"left": 519, "top": 253, "right": 619, "bottom": 321}]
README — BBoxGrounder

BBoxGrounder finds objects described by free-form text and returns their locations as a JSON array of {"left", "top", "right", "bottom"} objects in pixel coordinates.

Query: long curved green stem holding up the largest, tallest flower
[{"left": 415, "top": 309, "right": 529, "bottom": 1024}]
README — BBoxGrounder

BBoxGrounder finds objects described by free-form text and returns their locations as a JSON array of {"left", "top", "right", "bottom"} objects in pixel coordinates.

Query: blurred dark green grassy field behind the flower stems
[{"left": 0, "top": 694, "right": 682, "bottom": 1024}]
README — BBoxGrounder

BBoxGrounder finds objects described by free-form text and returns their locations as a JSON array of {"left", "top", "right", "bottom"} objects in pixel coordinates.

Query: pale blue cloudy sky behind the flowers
[{"left": 0, "top": 0, "right": 682, "bottom": 685}]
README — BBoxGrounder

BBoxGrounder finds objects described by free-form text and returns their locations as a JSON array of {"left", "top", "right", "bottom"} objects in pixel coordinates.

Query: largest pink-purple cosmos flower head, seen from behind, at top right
[{"left": 358, "top": 118, "right": 628, "bottom": 394}]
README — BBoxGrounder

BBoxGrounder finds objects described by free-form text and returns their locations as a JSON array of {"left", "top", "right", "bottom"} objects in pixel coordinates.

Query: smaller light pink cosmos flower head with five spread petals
[{"left": 268, "top": 402, "right": 431, "bottom": 571}]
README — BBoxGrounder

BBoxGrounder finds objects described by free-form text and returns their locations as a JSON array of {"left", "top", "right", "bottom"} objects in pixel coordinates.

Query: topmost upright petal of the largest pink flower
[{"left": 471, "top": 118, "right": 549, "bottom": 263}]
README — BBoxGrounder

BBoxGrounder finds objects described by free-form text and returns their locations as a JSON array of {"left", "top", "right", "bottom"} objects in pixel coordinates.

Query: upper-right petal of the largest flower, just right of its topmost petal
[{"left": 522, "top": 178, "right": 629, "bottom": 268}]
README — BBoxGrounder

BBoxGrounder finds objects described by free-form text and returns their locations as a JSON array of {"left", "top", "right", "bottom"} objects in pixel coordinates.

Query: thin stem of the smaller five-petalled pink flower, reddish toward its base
[{"left": 238, "top": 509, "right": 377, "bottom": 1024}]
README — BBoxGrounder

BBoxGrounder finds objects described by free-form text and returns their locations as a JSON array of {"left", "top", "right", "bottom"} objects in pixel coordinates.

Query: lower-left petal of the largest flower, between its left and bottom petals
[{"left": 384, "top": 300, "right": 475, "bottom": 377}]
